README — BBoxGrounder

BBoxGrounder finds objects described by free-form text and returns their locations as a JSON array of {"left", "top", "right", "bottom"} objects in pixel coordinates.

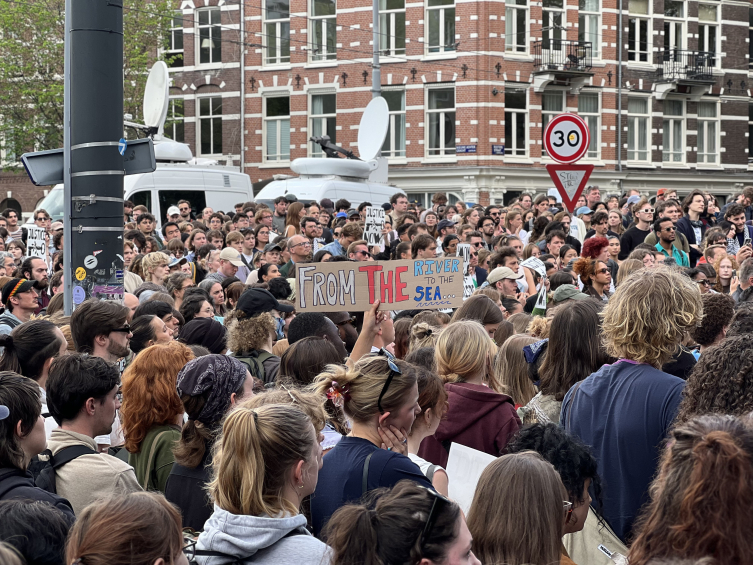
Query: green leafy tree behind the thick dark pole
[{"left": 0, "top": 0, "right": 173, "bottom": 168}]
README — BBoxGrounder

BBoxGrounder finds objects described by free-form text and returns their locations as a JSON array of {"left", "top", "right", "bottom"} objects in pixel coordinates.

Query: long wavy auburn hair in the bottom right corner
[{"left": 628, "top": 415, "right": 753, "bottom": 565}]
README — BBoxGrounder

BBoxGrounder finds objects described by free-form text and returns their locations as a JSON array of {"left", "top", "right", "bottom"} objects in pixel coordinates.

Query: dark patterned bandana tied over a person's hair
[{"left": 177, "top": 355, "right": 246, "bottom": 426}]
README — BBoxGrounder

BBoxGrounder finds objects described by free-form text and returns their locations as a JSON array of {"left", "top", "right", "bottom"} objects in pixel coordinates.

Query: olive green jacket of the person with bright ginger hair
[{"left": 128, "top": 426, "right": 180, "bottom": 493}]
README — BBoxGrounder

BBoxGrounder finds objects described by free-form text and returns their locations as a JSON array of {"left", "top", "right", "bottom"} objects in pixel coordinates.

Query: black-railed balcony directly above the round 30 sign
[{"left": 533, "top": 39, "right": 593, "bottom": 92}]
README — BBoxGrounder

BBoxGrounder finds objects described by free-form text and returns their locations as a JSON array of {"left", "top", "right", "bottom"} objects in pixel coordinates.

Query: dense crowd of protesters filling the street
[{"left": 0, "top": 186, "right": 753, "bottom": 565}]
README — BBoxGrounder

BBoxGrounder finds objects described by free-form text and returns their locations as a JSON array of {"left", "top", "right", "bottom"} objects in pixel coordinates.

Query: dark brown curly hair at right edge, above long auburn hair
[{"left": 675, "top": 334, "right": 753, "bottom": 425}]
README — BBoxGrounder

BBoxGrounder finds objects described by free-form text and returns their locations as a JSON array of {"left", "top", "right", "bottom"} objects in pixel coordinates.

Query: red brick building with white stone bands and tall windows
[{"left": 168, "top": 0, "right": 753, "bottom": 207}]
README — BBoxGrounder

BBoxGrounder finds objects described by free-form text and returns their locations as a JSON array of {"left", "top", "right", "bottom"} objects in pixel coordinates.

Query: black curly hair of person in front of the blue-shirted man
[{"left": 505, "top": 422, "right": 601, "bottom": 515}]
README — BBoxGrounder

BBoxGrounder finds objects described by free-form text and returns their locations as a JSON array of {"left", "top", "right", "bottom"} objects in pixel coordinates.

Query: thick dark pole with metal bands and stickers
[{"left": 64, "top": 0, "right": 125, "bottom": 308}]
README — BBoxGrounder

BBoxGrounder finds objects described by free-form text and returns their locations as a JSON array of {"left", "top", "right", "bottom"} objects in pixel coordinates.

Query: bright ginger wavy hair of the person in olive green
[{"left": 120, "top": 341, "right": 194, "bottom": 453}]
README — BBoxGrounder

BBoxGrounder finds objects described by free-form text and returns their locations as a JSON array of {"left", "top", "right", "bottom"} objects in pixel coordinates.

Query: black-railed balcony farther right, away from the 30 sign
[{"left": 656, "top": 49, "right": 718, "bottom": 100}]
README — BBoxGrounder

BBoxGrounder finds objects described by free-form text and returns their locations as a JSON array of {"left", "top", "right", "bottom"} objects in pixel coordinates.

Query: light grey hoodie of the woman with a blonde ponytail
[{"left": 196, "top": 505, "right": 330, "bottom": 565}]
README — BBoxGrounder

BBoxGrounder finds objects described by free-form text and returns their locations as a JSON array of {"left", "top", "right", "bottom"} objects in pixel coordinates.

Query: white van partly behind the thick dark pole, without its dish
[{"left": 29, "top": 138, "right": 254, "bottom": 226}]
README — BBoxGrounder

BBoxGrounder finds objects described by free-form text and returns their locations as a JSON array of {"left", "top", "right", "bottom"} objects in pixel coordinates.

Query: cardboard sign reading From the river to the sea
[{"left": 296, "top": 257, "right": 463, "bottom": 312}]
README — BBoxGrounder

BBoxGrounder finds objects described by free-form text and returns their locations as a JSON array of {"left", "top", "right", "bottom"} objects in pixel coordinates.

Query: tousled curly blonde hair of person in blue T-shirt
[{"left": 602, "top": 267, "right": 703, "bottom": 369}]
